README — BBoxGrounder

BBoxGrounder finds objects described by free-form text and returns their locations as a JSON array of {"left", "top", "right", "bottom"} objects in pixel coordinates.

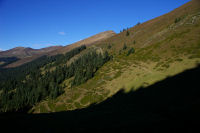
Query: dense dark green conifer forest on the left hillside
[{"left": 0, "top": 46, "right": 110, "bottom": 112}]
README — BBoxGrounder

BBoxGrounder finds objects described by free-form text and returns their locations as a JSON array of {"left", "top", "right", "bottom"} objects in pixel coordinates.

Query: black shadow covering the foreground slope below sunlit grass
[{"left": 0, "top": 67, "right": 200, "bottom": 133}]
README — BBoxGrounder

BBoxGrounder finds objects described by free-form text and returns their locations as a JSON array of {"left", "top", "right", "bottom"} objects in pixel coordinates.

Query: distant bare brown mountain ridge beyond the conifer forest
[{"left": 0, "top": 31, "right": 116, "bottom": 68}]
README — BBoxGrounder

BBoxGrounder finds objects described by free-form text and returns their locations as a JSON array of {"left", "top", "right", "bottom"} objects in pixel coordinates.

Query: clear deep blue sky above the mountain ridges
[{"left": 0, "top": 0, "right": 189, "bottom": 50}]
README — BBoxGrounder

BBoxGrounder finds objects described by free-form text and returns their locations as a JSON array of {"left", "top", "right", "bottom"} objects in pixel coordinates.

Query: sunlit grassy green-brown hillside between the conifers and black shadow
[{"left": 32, "top": 0, "right": 200, "bottom": 113}]
